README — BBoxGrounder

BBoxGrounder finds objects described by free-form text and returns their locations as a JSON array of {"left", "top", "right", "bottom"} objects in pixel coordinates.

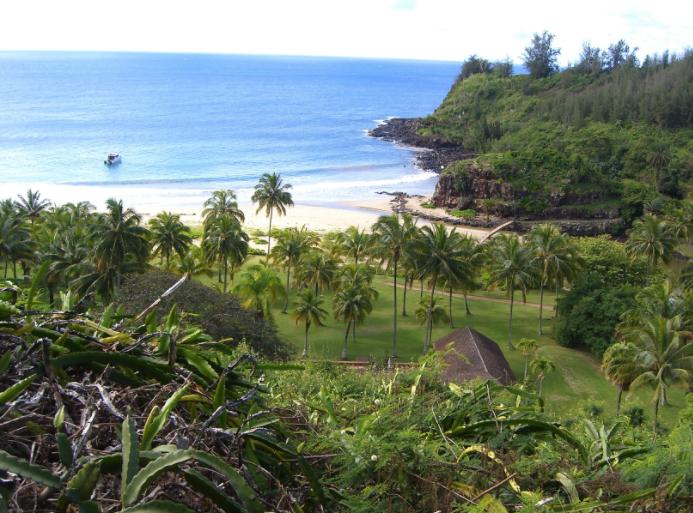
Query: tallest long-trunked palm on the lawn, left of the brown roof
[{"left": 373, "top": 214, "right": 416, "bottom": 357}]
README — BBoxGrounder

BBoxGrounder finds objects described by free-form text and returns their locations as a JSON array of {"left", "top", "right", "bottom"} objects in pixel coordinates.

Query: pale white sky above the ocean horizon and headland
[{"left": 0, "top": 0, "right": 693, "bottom": 65}]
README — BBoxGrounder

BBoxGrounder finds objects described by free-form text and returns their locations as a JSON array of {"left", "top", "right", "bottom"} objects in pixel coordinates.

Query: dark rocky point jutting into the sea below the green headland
[{"left": 368, "top": 118, "right": 474, "bottom": 173}]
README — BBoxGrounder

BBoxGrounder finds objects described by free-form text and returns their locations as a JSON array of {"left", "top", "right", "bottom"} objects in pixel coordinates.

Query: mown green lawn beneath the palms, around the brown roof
[{"left": 193, "top": 257, "right": 683, "bottom": 425}]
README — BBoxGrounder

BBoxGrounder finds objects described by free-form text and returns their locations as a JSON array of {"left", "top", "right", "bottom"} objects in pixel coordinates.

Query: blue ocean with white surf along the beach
[{"left": 0, "top": 52, "right": 459, "bottom": 212}]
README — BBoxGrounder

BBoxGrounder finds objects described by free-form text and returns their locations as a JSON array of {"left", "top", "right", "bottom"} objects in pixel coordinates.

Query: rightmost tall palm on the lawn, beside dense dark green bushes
[{"left": 528, "top": 224, "right": 578, "bottom": 336}]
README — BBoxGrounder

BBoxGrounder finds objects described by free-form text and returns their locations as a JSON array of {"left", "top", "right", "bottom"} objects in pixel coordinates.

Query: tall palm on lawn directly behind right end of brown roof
[{"left": 491, "top": 234, "right": 534, "bottom": 349}]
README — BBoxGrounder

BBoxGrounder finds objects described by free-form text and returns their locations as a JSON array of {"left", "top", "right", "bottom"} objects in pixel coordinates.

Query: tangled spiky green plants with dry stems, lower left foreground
[{"left": 0, "top": 286, "right": 326, "bottom": 513}]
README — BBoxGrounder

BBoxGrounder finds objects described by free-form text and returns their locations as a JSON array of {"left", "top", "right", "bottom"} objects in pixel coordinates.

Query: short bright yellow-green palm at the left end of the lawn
[{"left": 234, "top": 264, "right": 286, "bottom": 319}]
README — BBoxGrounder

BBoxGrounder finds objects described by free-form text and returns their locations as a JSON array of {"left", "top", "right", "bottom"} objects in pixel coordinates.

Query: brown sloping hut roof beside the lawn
[{"left": 434, "top": 327, "right": 515, "bottom": 385}]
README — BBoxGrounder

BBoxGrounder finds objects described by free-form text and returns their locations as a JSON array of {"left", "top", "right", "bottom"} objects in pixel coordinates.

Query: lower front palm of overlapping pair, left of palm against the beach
[{"left": 202, "top": 215, "right": 249, "bottom": 292}]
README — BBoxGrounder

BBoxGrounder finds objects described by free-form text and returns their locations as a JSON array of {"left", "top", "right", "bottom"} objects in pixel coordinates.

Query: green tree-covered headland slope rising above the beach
[{"left": 418, "top": 53, "right": 693, "bottom": 222}]
